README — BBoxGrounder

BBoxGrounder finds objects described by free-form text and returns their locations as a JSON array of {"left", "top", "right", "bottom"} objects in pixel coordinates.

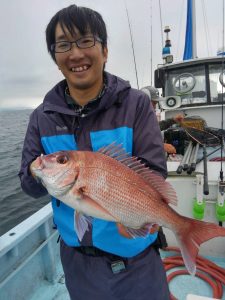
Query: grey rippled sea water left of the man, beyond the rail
[{"left": 0, "top": 109, "right": 50, "bottom": 235}]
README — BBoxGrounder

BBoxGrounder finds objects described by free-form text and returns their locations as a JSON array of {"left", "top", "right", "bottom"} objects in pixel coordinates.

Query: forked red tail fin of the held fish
[{"left": 176, "top": 217, "right": 225, "bottom": 275}]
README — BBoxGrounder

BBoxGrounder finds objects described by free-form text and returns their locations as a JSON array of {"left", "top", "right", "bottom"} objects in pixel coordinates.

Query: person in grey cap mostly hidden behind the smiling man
[{"left": 141, "top": 86, "right": 184, "bottom": 154}]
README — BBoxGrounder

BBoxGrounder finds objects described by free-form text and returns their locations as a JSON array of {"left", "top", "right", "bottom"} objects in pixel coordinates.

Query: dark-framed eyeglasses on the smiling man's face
[{"left": 51, "top": 36, "right": 102, "bottom": 53}]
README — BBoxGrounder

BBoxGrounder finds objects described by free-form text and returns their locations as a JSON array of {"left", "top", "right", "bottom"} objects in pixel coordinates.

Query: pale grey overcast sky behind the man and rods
[{"left": 0, "top": 0, "right": 223, "bottom": 108}]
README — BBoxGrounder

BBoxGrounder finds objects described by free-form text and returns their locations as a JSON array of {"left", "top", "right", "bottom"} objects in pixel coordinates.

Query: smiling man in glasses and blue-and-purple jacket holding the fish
[{"left": 19, "top": 5, "right": 169, "bottom": 300}]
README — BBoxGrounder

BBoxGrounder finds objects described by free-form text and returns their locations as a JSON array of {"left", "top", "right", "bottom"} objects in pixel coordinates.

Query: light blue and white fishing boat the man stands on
[{"left": 0, "top": 1, "right": 225, "bottom": 300}]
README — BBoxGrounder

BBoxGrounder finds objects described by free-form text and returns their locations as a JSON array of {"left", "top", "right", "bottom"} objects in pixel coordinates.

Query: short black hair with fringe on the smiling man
[{"left": 45, "top": 4, "right": 107, "bottom": 62}]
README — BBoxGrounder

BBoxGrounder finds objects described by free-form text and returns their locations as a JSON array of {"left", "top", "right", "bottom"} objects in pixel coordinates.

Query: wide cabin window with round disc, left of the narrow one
[{"left": 165, "top": 65, "right": 207, "bottom": 106}]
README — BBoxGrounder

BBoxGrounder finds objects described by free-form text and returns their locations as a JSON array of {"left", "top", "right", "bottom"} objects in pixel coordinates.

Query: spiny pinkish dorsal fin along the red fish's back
[{"left": 98, "top": 142, "right": 177, "bottom": 205}]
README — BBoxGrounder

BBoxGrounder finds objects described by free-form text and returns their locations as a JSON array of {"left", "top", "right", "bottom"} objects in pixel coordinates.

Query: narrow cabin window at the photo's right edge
[{"left": 209, "top": 64, "right": 225, "bottom": 103}]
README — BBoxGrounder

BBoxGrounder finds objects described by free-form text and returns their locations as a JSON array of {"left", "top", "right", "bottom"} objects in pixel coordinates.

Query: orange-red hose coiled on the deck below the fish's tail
[{"left": 163, "top": 247, "right": 225, "bottom": 300}]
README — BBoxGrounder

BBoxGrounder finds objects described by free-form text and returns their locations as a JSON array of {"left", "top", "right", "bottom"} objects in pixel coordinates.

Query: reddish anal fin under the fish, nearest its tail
[{"left": 117, "top": 223, "right": 159, "bottom": 239}]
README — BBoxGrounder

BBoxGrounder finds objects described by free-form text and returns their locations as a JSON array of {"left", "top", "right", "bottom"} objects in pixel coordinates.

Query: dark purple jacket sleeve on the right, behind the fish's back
[{"left": 133, "top": 95, "right": 167, "bottom": 178}]
